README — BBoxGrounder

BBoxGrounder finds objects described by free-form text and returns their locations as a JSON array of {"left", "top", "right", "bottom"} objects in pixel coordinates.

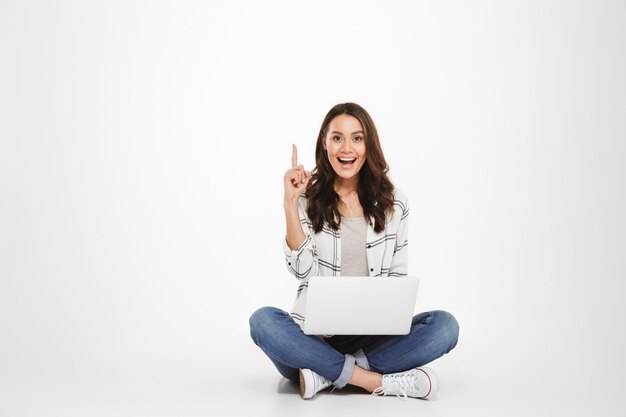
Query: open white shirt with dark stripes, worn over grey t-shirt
[{"left": 283, "top": 188, "right": 409, "bottom": 326}]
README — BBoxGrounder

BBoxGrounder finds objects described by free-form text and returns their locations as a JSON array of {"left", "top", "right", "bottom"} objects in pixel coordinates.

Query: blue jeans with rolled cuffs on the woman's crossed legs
[{"left": 250, "top": 307, "right": 459, "bottom": 388}]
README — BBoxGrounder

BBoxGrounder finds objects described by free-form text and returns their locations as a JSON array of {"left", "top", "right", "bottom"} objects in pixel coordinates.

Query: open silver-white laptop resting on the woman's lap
[{"left": 302, "top": 276, "right": 419, "bottom": 335}]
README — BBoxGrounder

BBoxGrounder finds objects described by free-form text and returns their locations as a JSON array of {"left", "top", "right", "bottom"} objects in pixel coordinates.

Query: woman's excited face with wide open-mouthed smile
[{"left": 323, "top": 114, "right": 366, "bottom": 179}]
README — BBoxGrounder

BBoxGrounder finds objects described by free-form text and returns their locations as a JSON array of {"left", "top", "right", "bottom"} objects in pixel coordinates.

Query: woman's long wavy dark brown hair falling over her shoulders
[{"left": 304, "top": 103, "right": 393, "bottom": 233}]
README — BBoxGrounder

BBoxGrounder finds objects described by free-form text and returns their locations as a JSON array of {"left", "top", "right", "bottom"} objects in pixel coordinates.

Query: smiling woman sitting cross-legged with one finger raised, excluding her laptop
[{"left": 250, "top": 103, "right": 459, "bottom": 399}]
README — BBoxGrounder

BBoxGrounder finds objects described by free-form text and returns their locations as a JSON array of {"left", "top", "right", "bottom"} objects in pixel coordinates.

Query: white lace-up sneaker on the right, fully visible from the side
[{"left": 372, "top": 366, "right": 439, "bottom": 400}]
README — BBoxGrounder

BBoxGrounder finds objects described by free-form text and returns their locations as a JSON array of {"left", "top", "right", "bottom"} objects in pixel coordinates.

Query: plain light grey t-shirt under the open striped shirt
[{"left": 341, "top": 217, "right": 369, "bottom": 277}]
